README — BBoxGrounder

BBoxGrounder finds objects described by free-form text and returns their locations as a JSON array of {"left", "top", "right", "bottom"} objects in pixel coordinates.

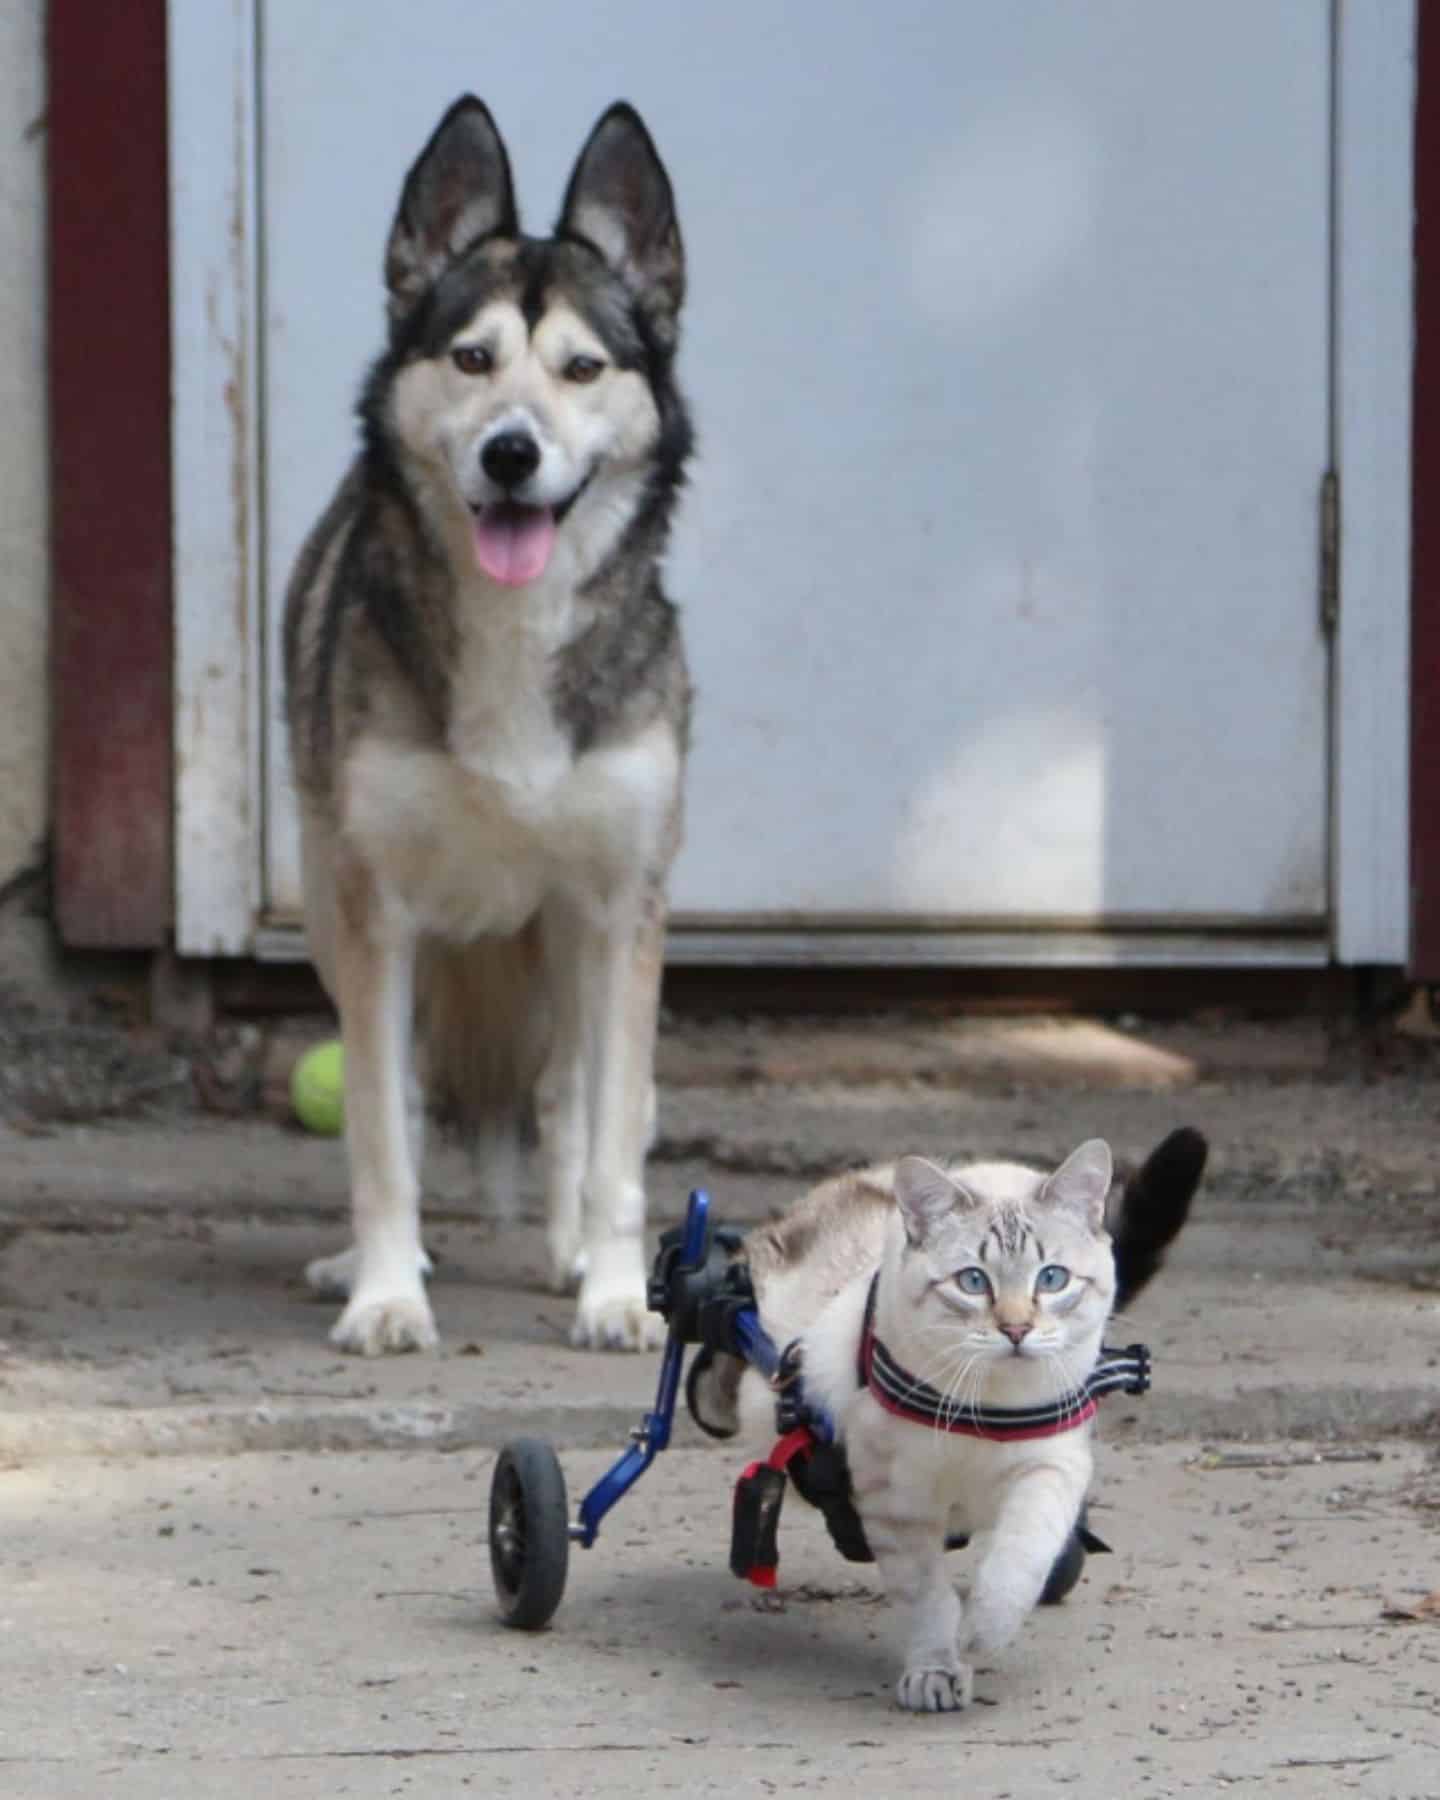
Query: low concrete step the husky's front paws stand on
[{"left": 0, "top": 1132, "right": 1440, "bottom": 1462}]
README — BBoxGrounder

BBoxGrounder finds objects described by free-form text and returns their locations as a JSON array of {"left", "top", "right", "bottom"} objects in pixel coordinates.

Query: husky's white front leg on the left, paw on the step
[{"left": 331, "top": 864, "right": 436, "bottom": 1355}]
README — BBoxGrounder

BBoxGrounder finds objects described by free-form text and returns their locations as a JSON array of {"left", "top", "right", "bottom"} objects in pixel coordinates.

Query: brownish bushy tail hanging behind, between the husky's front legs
[{"left": 416, "top": 925, "right": 551, "bottom": 1188}]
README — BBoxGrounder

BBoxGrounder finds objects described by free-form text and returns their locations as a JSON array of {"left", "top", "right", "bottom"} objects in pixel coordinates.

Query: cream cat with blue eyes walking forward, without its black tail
[{"left": 738, "top": 1138, "right": 1116, "bottom": 1712}]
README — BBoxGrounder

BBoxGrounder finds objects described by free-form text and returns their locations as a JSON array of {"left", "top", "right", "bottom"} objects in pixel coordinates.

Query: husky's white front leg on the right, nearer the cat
[{"left": 571, "top": 895, "right": 664, "bottom": 1350}]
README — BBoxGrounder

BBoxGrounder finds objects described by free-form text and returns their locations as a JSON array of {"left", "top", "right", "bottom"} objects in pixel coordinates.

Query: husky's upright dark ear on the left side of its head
[{"left": 385, "top": 94, "right": 518, "bottom": 319}]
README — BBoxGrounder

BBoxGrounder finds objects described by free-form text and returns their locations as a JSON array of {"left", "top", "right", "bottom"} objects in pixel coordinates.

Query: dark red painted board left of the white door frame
[{"left": 47, "top": 0, "right": 175, "bottom": 949}]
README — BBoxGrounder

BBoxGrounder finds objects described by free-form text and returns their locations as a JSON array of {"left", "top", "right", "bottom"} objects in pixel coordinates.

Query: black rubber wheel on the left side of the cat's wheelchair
[{"left": 490, "top": 1438, "right": 571, "bottom": 1631}]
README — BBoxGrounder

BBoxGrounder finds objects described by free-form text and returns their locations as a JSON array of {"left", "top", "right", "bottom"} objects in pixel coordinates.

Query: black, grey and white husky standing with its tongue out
[{"left": 284, "top": 95, "right": 691, "bottom": 1355}]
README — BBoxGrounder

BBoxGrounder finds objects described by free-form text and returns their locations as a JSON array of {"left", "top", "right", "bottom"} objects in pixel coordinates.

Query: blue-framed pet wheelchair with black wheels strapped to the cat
[{"left": 490, "top": 1188, "right": 1150, "bottom": 1631}]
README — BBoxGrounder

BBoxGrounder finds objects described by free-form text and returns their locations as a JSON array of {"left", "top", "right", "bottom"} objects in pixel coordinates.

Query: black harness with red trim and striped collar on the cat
[{"left": 731, "top": 1274, "right": 1150, "bottom": 1588}]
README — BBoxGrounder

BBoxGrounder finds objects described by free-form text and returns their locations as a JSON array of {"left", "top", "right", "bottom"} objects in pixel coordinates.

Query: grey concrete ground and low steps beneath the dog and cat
[{"left": 0, "top": 1021, "right": 1440, "bottom": 1800}]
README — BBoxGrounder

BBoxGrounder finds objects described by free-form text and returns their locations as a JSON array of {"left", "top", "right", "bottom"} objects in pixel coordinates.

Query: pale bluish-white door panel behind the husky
[{"left": 259, "top": 0, "right": 1330, "bottom": 947}]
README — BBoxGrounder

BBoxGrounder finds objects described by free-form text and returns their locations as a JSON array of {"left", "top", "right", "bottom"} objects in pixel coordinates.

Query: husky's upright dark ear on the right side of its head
[{"left": 556, "top": 101, "right": 686, "bottom": 344}]
